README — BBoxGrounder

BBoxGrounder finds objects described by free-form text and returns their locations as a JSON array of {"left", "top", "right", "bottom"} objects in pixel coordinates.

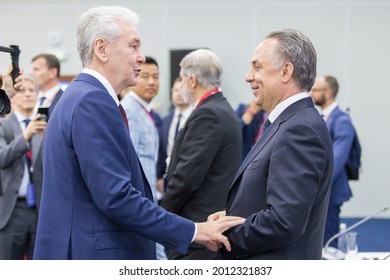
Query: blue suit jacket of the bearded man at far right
[{"left": 326, "top": 107, "right": 355, "bottom": 206}]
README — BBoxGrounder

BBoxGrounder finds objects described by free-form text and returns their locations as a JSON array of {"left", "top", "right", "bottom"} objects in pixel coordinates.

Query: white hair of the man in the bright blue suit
[{"left": 77, "top": 6, "right": 139, "bottom": 67}]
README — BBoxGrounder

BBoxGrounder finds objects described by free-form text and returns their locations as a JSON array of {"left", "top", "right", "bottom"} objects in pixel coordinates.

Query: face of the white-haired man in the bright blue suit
[{"left": 104, "top": 21, "right": 145, "bottom": 93}]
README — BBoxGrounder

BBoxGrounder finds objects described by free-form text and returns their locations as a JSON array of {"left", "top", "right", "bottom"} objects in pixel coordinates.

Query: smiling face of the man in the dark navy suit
[{"left": 246, "top": 38, "right": 284, "bottom": 112}]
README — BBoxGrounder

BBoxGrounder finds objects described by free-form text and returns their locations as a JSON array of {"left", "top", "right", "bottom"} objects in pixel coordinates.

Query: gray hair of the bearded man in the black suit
[{"left": 180, "top": 49, "right": 222, "bottom": 88}]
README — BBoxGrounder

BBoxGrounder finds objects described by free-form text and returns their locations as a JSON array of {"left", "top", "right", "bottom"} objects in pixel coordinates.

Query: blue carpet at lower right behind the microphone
[{"left": 341, "top": 218, "right": 390, "bottom": 252}]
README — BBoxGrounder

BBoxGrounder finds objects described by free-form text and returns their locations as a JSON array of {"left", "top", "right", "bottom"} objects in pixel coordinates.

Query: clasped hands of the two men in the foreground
[{"left": 194, "top": 211, "right": 245, "bottom": 252}]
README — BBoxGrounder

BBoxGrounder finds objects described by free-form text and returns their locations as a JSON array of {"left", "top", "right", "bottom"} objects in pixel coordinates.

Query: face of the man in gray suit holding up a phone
[{"left": 12, "top": 79, "right": 38, "bottom": 115}]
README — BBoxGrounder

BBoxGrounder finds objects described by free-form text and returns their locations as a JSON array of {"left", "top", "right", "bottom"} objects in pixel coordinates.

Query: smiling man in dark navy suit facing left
[{"left": 215, "top": 29, "right": 333, "bottom": 259}]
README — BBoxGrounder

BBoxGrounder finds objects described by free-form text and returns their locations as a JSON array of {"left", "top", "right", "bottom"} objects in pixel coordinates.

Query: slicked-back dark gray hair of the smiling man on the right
[{"left": 265, "top": 29, "right": 317, "bottom": 91}]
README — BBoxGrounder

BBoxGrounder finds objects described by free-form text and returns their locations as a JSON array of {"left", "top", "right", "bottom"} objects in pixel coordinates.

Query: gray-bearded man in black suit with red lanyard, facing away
[{"left": 162, "top": 49, "right": 242, "bottom": 259}]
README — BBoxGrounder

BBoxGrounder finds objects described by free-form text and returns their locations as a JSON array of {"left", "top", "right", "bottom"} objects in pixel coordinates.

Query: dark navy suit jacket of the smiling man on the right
[{"left": 218, "top": 97, "right": 333, "bottom": 259}]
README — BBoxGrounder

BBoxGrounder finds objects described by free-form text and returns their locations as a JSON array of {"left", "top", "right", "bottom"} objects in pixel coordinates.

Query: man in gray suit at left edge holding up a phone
[{"left": 0, "top": 76, "right": 46, "bottom": 260}]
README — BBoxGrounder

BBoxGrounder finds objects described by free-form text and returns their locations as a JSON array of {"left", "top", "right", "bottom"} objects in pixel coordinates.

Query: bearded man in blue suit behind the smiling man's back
[{"left": 311, "top": 76, "right": 356, "bottom": 247}]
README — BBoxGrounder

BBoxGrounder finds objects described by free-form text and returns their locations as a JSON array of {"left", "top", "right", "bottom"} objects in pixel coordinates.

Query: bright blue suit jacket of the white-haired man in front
[{"left": 34, "top": 73, "right": 194, "bottom": 259}]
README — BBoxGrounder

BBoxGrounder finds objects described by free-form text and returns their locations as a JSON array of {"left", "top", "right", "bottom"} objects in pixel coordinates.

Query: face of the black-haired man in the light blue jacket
[{"left": 132, "top": 64, "right": 160, "bottom": 103}]
